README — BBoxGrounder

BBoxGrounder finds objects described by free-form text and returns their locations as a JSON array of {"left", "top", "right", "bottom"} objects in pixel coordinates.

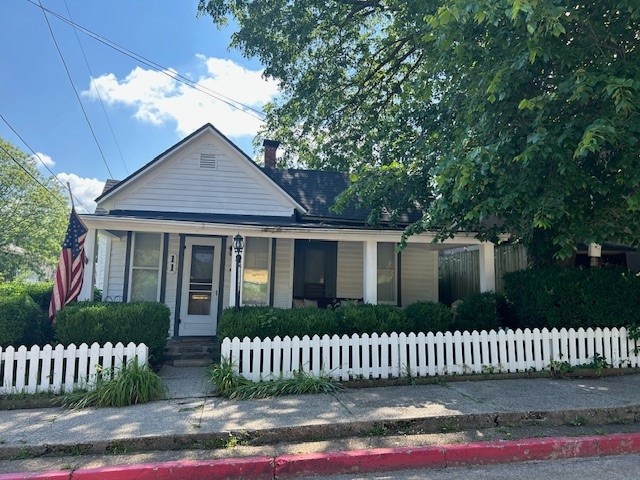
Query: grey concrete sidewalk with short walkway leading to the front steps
[{"left": 0, "top": 366, "right": 640, "bottom": 471}]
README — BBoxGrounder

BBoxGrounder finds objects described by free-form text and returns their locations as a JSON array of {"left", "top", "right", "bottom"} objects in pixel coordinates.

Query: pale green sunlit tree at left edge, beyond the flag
[{"left": 0, "top": 139, "right": 68, "bottom": 280}]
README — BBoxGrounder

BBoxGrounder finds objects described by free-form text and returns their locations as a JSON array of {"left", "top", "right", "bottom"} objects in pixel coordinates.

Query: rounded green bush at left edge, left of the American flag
[{"left": 0, "top": 293, "right": 52, "bottom": 347}]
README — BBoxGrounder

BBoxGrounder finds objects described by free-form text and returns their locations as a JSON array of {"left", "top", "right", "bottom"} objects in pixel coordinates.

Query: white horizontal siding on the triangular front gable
[{"left": 104, "top": 136, "right": 293, "bottom": 216}]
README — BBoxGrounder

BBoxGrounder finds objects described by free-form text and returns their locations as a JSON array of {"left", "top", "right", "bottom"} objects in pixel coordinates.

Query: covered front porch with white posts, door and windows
[{"left": 80, "top": 215, "right": 495, "bottom": 337}]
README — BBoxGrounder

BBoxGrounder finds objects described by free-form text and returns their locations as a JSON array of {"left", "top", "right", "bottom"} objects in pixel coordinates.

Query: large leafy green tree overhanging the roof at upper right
[{"left": 199, "top": 0, "right": 640, "bottom": 257}]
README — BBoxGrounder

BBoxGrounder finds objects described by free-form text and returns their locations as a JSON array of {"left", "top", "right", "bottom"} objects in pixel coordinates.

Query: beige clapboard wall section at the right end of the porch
[{"left": 401, "top": 244, "right": 438, "bottom": 307}]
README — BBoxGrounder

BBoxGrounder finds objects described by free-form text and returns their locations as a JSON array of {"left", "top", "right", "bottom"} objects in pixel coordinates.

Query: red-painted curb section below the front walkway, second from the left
[{"left": 69, "top": 457, "right": 273, "bottom": 480}]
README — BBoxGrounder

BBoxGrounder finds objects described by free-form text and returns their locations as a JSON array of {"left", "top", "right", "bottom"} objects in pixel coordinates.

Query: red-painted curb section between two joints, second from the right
[{"left": 275, "top": 447, "right": 446, "bottom": 478}]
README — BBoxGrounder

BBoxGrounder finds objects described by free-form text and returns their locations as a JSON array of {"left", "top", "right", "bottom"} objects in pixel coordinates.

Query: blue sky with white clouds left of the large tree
[{"left": 0, "top": 0, "right": 277, "bottom": 211}]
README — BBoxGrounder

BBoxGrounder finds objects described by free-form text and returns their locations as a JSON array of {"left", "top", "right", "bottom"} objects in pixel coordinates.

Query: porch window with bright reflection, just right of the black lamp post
[{"left": 242, "top": 237, "right": 269, "bottom": 305}]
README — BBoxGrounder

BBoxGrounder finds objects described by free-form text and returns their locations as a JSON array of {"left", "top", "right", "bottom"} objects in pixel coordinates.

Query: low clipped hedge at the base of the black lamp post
[{"left": 218, "top": 307, "right": 336, "bottom": 338}]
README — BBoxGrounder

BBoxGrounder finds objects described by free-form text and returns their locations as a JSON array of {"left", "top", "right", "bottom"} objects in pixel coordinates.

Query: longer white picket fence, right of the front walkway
[{"left": 221, "top": 328, "right": 639, "bottom": 381}]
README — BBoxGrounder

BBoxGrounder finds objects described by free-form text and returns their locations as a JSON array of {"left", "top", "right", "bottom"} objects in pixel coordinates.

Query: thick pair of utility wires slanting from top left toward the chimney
[{"left": 26, "top": 0, "right": 264, "bottom": 122}]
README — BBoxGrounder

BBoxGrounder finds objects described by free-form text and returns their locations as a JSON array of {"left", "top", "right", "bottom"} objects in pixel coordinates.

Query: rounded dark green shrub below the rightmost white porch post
[{"left": 453, "top": 292, "right": 507, "bottom": 332}]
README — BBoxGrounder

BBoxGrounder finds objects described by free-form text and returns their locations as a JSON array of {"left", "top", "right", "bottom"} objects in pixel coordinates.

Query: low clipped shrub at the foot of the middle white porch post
[{"left": 335, "top": 304, "right": 412, "bottom": 335}]
